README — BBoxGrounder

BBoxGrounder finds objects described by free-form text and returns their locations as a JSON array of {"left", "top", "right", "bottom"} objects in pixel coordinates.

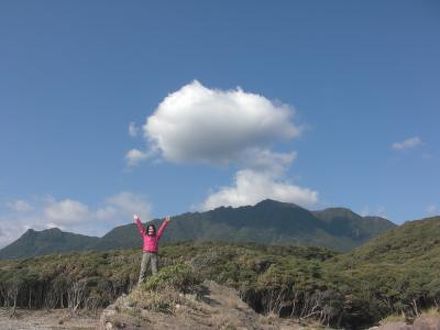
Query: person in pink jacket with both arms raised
[{"left": 133, "top": 214, "right": 170, "bottom": 284}]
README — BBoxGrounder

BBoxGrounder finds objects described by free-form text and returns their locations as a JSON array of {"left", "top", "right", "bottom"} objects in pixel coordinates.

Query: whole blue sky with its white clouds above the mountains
[{"left": 0, "top": 0, "right": 440, "bottom": 244}]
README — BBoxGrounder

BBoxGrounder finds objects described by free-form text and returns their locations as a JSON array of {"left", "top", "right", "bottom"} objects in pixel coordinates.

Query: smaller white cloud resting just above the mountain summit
[{"left": 201, "top": 170, "right": 318, "bottom": 210}]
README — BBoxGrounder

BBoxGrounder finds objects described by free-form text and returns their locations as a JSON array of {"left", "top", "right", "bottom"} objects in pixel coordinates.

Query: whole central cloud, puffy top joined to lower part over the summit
[{"left": 126, "top": 81, "right": 318, "bottom": 210}]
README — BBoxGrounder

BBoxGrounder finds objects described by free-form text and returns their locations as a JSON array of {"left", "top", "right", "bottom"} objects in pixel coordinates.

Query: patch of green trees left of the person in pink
[{"left": 0, "top": 251, "right": 139, "bottom": 313}]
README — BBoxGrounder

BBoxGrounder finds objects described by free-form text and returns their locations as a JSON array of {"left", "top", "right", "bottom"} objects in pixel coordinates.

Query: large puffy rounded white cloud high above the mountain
[{"left": 143, "top": 81, "right": 300, "bottom": 164}]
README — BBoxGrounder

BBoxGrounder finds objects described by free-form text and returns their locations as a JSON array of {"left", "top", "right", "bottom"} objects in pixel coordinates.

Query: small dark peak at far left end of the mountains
[{"left": 0, "top": 228, "right": 99, "bottom": 259}]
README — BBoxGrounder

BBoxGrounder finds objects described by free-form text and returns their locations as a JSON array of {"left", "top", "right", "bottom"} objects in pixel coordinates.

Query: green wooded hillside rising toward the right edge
[{"left": 316, "top": 217, "right": 440, "bottom": 324}]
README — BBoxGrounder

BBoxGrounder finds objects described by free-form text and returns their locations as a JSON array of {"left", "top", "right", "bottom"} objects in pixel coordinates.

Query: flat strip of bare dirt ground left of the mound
[{"left": 0, "top": 308, "right": 100, "bottom": 330}]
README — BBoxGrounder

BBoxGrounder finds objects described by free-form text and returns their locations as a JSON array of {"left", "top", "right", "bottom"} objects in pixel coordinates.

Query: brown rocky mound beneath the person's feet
[{"left": 100, "top": 281, "right": 304, "bottom": 330}]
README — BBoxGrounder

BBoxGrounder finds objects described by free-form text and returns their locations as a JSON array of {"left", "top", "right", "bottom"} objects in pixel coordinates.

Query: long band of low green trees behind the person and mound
[{"left": 0, "top": 237, "right": 440, "bottom": 328}]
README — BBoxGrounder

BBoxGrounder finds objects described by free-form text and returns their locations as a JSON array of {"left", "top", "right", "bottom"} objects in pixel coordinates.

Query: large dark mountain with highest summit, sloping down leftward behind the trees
[{"left": 0, "top": 200, "right": 396, "bottom": 258}]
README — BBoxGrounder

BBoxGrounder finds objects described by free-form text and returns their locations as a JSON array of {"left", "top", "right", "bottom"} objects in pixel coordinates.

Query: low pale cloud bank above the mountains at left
[{"left": 0, "top": 192, "right": 151, "bottom": 248}]
